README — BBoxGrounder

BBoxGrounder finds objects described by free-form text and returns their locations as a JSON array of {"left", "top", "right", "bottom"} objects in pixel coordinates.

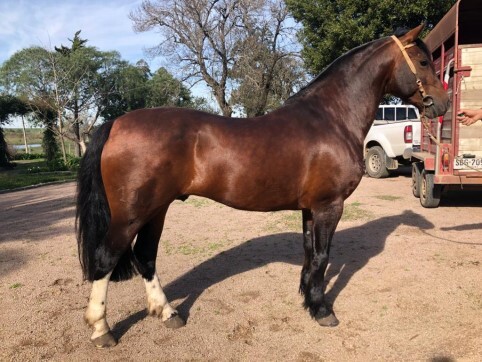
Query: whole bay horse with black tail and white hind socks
[{"left": 76, "top": 25, "right": 449, "bottom": 348}]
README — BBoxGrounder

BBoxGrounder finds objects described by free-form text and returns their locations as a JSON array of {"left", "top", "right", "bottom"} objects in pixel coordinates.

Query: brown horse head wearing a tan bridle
[{"left": 387, "top": 24, "right": 449, "bottom": 118}]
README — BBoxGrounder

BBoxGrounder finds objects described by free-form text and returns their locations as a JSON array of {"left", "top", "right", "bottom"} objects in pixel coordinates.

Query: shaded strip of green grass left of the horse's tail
[{"left": 0, "top": 159, "right": 77, "bottom": 191}]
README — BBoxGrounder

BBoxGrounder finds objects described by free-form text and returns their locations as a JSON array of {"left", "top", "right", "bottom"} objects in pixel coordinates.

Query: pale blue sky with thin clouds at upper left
[{"left": 0, "top": 0, "right": 161, "bottom": 70}]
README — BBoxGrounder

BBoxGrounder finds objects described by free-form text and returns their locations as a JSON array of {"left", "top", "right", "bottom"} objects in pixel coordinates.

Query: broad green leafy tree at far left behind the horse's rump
[{"left": 0, "top": 42, "right": 145, "bottom": 157}]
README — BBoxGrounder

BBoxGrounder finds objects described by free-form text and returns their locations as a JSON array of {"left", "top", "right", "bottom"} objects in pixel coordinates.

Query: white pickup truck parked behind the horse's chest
[{"left": 364, "top": 105, "right": 420, "bottom": 178}]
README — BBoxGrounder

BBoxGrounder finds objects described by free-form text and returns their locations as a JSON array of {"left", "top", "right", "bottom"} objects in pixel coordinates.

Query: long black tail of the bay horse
[{"left": 76, "top": 121, "right": 136, "bottom": 281}]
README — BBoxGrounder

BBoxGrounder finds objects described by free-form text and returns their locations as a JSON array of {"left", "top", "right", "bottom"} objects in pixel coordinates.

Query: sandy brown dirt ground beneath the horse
[{"left": 0, "top": 170, "right": 482, "bottom": 361}]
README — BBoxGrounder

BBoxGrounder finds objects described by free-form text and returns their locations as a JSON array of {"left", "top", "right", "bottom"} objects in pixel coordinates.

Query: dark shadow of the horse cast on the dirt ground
[{"left": 113, "top": 210, "right": 434, "bottom": 337}]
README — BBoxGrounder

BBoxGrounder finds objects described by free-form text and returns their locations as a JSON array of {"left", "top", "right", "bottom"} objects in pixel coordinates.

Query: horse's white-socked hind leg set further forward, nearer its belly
[{"left": 134, "top": 207, "right": 186, "bottom": 328}]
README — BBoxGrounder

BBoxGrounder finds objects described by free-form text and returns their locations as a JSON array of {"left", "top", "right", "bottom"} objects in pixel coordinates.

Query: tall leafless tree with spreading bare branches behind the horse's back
[{"left": 129, "top": 0, "right": 302, "bottom": 116}]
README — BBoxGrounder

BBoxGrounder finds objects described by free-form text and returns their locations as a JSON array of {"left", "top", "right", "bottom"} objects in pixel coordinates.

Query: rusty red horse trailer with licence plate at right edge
[{"left": 412, "top": 0, "right": 482, "bottom": 208}]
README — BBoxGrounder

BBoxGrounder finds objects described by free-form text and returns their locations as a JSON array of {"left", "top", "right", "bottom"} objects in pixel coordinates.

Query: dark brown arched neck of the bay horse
[{"left": 300, "top": 38, "right": 393, "bottom": 143}]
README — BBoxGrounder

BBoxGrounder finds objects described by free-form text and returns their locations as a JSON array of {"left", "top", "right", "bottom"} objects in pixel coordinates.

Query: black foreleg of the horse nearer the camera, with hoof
[{"left": 305, "top": 200, "right": 343, "bottom": 327}]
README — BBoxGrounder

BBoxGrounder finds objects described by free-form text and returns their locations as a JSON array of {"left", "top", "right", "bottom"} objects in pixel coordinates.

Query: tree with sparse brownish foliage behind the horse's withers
[{"left": 231, "top": 2, "right": 305, "bottom": 117}]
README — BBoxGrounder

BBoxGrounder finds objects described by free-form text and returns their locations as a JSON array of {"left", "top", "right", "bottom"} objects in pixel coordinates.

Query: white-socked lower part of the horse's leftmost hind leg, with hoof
[{"left": 84, "top": 271, "right": 117, "bottom": 348}]
